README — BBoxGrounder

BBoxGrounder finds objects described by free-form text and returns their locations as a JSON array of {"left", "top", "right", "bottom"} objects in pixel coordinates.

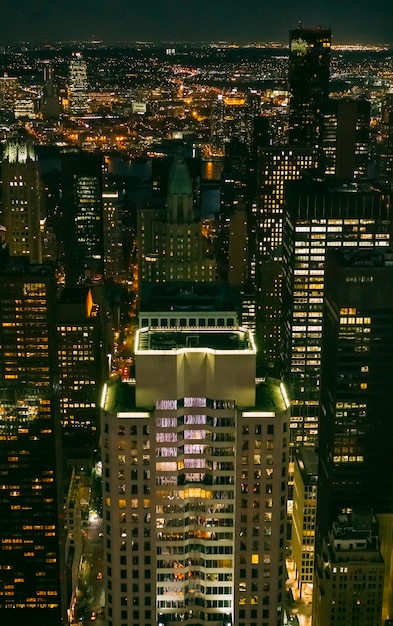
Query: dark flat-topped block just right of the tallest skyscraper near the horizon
[{"left": 321, "top": 98, "right": 370, "bottom": 180}]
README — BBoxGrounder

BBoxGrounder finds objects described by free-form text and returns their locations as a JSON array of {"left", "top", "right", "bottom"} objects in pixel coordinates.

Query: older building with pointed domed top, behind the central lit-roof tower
[{"left": 137, "top": 156, "right": 216, "bottom": 282}]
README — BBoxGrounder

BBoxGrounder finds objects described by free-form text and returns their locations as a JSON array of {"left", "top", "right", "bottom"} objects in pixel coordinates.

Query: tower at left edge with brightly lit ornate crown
[{"left": 2, "top": 139, "right": 43, "bottom": 263}]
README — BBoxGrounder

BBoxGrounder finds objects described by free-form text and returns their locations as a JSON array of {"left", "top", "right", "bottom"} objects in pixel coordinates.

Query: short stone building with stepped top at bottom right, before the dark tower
[{"left": 312, "top": 510, "right": 384, "bottom": 626}]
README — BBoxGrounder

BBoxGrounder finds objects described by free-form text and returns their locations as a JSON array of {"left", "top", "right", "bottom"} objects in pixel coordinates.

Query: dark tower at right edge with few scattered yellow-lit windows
[{"left": 318, "top": 248, "right": 393, "bottom": 619}]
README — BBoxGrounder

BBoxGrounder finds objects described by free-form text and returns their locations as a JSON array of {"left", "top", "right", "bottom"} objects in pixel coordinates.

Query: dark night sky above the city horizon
[{"left": 0, "top": 0, "right": 393, "bottom": 44}]
